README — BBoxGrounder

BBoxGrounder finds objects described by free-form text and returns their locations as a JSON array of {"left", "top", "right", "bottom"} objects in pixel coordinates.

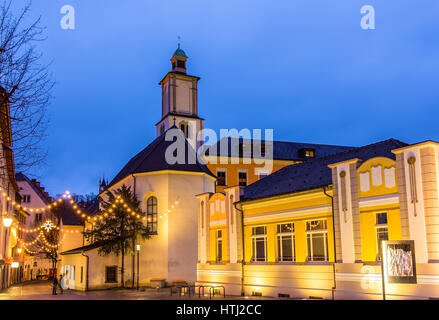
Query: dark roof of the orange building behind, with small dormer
[{"left": 208, "top": 138, "right": 353, "bottom": 161}]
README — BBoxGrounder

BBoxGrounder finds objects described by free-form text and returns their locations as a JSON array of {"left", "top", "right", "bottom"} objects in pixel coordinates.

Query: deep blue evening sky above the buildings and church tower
[{"left": 13, "top": 0, "right": 439, "bottom": 194}]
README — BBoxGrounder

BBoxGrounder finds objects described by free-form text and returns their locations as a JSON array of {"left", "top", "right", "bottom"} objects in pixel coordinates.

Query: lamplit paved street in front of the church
[{"left": 0, "top": 280, "right": 260, "bottom": 300}]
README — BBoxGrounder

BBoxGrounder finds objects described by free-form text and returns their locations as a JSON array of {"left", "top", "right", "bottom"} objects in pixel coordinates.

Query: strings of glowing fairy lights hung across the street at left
[{"left": 0, "top": 188, "right": 179, "bottom": 254}]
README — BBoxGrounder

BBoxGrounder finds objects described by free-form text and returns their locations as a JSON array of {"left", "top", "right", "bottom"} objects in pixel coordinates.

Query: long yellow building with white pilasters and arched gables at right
[{"left": 197, "top": 139, "right": 439, "bottom": 299}]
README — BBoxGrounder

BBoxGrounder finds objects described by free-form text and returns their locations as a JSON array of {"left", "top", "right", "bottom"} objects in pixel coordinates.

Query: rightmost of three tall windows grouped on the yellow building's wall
[{"left": 306, "top": 220, "right": 328, "bottom": 261}]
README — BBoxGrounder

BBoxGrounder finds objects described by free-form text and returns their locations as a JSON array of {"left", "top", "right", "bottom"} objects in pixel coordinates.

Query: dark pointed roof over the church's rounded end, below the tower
[{"left": 107, "top": 126, "right": 214, "bottom": 188}]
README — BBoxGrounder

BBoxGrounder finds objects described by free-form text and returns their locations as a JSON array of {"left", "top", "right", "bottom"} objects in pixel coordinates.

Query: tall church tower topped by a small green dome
[{"left": 156, "top": 44, "right": 204, "bottom": 150}]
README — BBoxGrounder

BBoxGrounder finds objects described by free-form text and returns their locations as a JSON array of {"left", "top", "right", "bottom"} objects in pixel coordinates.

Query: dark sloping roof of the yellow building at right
[{"left": 243, "top": 139, "right": 408, "bottom": 201}]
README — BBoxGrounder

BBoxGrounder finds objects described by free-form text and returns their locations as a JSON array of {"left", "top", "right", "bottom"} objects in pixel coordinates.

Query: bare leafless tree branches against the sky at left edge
[{"left": 0, "top": 0, "right": 55, "bottom": 173}]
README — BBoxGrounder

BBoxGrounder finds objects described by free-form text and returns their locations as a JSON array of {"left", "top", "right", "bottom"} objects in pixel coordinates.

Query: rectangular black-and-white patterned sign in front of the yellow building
[{"left": 382, "top": 240, "right": 416, "bottom": 283}]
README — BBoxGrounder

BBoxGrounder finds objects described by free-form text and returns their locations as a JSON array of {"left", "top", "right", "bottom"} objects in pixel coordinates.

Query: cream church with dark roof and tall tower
[{"left": 59, "top": 48, "right": 216, "bottom": 290}]
